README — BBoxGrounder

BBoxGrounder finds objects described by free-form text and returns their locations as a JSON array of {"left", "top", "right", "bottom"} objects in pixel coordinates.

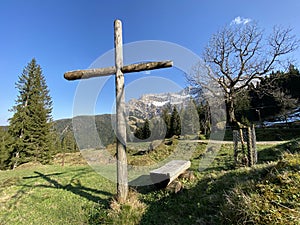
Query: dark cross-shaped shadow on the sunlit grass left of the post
[{"left": 23, "top": 171, "right": 112, "bottom": 205}]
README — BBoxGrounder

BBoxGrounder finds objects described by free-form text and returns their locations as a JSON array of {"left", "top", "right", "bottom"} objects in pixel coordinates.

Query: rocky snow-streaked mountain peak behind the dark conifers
[{"left": 126, "top": 89, "right": 191, "bottom": 119}]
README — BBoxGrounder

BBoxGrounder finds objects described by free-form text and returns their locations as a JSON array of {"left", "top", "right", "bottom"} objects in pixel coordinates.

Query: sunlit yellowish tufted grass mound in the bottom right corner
[{"left": 221, "top": 154, "right": 300, "bottom": 225}]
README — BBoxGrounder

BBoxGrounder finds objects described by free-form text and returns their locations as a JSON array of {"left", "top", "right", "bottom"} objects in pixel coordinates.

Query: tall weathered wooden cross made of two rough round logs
[{"left": 64, "top": 20, "right": 173, "bottom": 202}]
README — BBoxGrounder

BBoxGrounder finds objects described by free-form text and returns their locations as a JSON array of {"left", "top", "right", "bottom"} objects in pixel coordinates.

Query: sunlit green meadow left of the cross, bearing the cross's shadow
[{"left": 0, "top": 165, "right": 115, "bottom": 224}]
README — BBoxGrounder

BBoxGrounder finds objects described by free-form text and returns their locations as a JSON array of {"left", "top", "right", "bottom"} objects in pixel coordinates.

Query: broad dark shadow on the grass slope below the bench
[{"left": 140, "top": 163, "right": 271, "bottom": 225}]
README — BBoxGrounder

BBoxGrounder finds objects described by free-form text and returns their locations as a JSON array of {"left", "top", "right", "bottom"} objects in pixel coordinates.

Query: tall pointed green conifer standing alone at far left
[{"left": 8, "top": 59, "right": 53, "bottom": 168}]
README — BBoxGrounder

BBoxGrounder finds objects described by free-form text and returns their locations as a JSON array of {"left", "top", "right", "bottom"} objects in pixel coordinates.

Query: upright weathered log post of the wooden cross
[{"left": 114, "top": 20, "right": 128, "bottom": 202}]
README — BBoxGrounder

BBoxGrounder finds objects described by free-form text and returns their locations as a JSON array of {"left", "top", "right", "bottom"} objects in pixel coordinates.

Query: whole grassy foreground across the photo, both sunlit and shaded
[{"left": 0, "top": 139, "right": 300, "bottom": 224}]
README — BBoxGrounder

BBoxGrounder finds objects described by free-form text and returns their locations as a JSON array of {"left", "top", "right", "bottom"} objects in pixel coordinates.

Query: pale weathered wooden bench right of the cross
[{"left": 150, "top": 160, "right": 191, "bottom": 187}]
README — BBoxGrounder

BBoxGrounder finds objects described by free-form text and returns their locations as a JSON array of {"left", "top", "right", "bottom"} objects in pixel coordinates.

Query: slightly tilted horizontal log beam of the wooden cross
[{"left": 64, "top": 60, "right": 173, "bottom": 80}]
